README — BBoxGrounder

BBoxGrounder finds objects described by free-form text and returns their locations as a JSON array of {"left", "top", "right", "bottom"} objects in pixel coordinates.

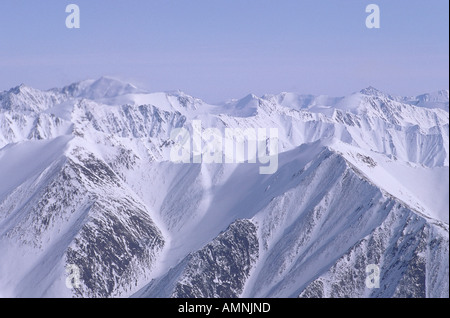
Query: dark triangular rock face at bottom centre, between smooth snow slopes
[{"left": 134, "top": 220, "right": 259, "bottom": 298}]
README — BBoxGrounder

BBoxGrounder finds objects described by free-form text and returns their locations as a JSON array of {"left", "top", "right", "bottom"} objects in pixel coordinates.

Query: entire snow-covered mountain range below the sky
[{"left": 0, "top": 77, "right": 449, "bottom": 297}]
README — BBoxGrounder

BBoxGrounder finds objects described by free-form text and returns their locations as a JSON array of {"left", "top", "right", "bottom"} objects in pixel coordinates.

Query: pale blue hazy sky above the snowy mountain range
[{"left": 0, "top": 0, "right": 449, "bottom": 102}]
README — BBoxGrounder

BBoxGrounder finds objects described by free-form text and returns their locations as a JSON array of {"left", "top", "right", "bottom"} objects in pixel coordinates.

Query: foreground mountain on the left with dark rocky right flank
[{"left": 0, "top": 137, "right": 164, "bottom": 297}]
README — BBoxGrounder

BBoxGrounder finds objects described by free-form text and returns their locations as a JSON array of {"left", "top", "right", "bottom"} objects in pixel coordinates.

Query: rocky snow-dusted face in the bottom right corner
[{"left": 299, "top": 214, "right": 448, "bottom": 298}]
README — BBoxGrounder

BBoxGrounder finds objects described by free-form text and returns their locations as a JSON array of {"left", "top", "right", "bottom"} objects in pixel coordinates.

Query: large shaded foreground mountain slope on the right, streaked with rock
[{"left": 134, "top": 145, "right": 449, "bottom": 297}]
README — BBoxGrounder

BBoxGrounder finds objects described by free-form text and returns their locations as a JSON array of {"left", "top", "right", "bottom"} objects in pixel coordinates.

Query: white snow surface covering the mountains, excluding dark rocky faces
[{"left": 0, "top": 77, "right": 449, "bottom": 297}]
